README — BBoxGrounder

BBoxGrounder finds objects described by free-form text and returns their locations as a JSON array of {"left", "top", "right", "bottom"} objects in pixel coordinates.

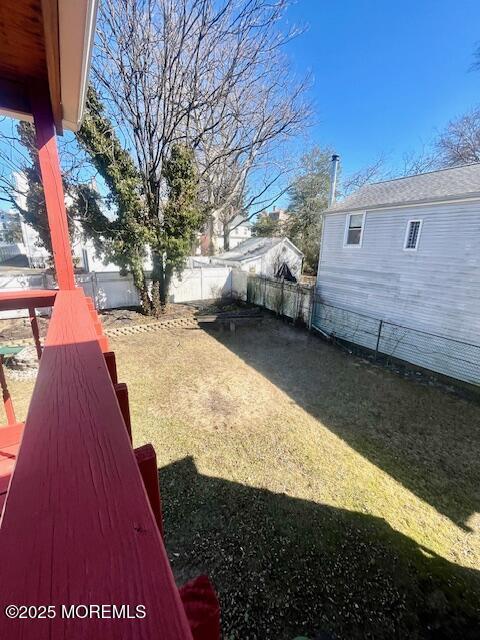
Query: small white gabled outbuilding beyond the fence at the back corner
[{"left": 211, "top": 238, "right": 303, "bottom": 280}]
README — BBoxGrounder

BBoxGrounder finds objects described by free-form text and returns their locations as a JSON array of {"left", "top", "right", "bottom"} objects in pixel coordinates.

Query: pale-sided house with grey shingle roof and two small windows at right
[{"left": 314, "top": 164, "right": 480, "bottom": 383}]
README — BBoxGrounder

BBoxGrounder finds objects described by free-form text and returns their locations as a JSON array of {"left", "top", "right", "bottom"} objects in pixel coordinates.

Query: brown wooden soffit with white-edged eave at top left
[{"left": 0, "top": 0, "right": 97, "bottom": 133}]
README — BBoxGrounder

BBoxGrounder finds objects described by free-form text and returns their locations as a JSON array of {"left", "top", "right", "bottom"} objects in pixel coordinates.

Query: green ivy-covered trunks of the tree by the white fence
[{"left": 77, "top": 87, "right": 205, "bottom": 315}]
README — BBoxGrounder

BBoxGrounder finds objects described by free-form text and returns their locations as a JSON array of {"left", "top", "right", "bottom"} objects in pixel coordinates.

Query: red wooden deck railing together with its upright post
[{"left": 0, "top": 77, "right": 220, "bottom": 640}]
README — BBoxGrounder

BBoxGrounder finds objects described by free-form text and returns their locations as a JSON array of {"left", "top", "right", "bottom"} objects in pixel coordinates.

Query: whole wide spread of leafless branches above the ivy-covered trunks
[{"left": 93, "top": 0, "right": 308, "bottom": 264}]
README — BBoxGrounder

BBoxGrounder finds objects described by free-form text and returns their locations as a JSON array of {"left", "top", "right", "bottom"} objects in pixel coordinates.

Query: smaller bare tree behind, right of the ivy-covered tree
[{"left": 198, "top": 58, "right": 309, "bottom": 250}]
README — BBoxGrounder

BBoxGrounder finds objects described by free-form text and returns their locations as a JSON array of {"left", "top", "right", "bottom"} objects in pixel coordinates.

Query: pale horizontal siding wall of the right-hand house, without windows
[{"left": 317, "top": 202, "right": 480, "bottom": 375}]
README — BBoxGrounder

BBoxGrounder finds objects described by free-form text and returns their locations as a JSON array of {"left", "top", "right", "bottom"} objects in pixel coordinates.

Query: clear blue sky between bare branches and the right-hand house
[{"left": 287, "top": 0, "right": 480, "bottom": 173}]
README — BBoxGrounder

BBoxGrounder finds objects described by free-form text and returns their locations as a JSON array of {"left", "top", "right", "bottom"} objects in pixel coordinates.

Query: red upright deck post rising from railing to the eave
[{"left": 30, "top": 85, "right": 75, "bottom": 289}]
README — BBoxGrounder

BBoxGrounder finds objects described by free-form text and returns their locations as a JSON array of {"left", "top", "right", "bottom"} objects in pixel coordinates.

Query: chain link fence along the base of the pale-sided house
[{"left": 311, "top": 296, "right": 480, "bottom": 385}]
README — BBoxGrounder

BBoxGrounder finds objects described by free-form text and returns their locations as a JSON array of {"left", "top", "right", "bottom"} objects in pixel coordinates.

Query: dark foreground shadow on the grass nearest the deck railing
[{"left": 159, "top": 458, "right": 480, "bottom": 640}]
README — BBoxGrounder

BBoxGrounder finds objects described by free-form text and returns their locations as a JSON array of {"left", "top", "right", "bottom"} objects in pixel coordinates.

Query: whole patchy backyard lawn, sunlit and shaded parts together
[{"left": 4, "top": 319, "right": 480, "bottom": 640}]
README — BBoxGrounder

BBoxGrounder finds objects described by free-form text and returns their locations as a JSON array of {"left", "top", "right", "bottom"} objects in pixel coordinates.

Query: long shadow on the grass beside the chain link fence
[{"left": 202, "top": 319, "right": 480, "bottom": 531}]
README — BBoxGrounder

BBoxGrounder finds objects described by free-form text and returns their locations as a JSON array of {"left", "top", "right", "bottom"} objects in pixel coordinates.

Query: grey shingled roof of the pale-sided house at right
[{"left": 326, "top": 163, "right": 480, "bottom": 213}]
